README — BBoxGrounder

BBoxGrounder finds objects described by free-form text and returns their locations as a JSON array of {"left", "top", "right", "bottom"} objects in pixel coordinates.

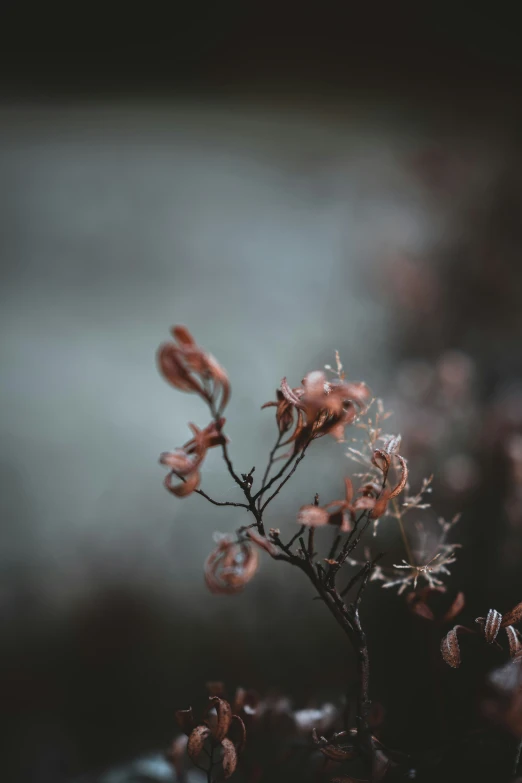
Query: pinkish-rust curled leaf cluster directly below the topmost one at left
[{"left": 159, "top": 419, "right": 227, "bottom": 497}]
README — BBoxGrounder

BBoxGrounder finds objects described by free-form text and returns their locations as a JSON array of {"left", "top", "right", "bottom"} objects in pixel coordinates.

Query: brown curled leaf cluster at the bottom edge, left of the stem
[{"left": 176, "top": 696, "right": 246, "bottom": 779}]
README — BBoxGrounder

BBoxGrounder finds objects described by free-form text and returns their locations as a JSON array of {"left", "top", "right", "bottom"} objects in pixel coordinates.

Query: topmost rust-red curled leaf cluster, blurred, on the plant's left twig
[{"left": 158, "top": 326, "right": 230, "bottom": 414}]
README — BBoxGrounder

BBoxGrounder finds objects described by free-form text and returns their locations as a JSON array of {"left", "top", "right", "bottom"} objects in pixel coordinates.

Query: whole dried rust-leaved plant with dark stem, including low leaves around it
[{"left": 158, "top": 326, "right": 522, "bottom": 782}]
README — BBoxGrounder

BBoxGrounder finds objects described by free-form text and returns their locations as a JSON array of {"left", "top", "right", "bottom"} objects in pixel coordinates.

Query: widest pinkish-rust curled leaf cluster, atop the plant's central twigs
[{"left": 281, "top": 370, "right": 370, "bottom": 443}]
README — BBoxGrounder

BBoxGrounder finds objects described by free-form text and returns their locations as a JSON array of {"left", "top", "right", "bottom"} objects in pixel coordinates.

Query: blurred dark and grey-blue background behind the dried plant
[{"left": 0, "top": 3, "right": 522, "bottom": 783}]
